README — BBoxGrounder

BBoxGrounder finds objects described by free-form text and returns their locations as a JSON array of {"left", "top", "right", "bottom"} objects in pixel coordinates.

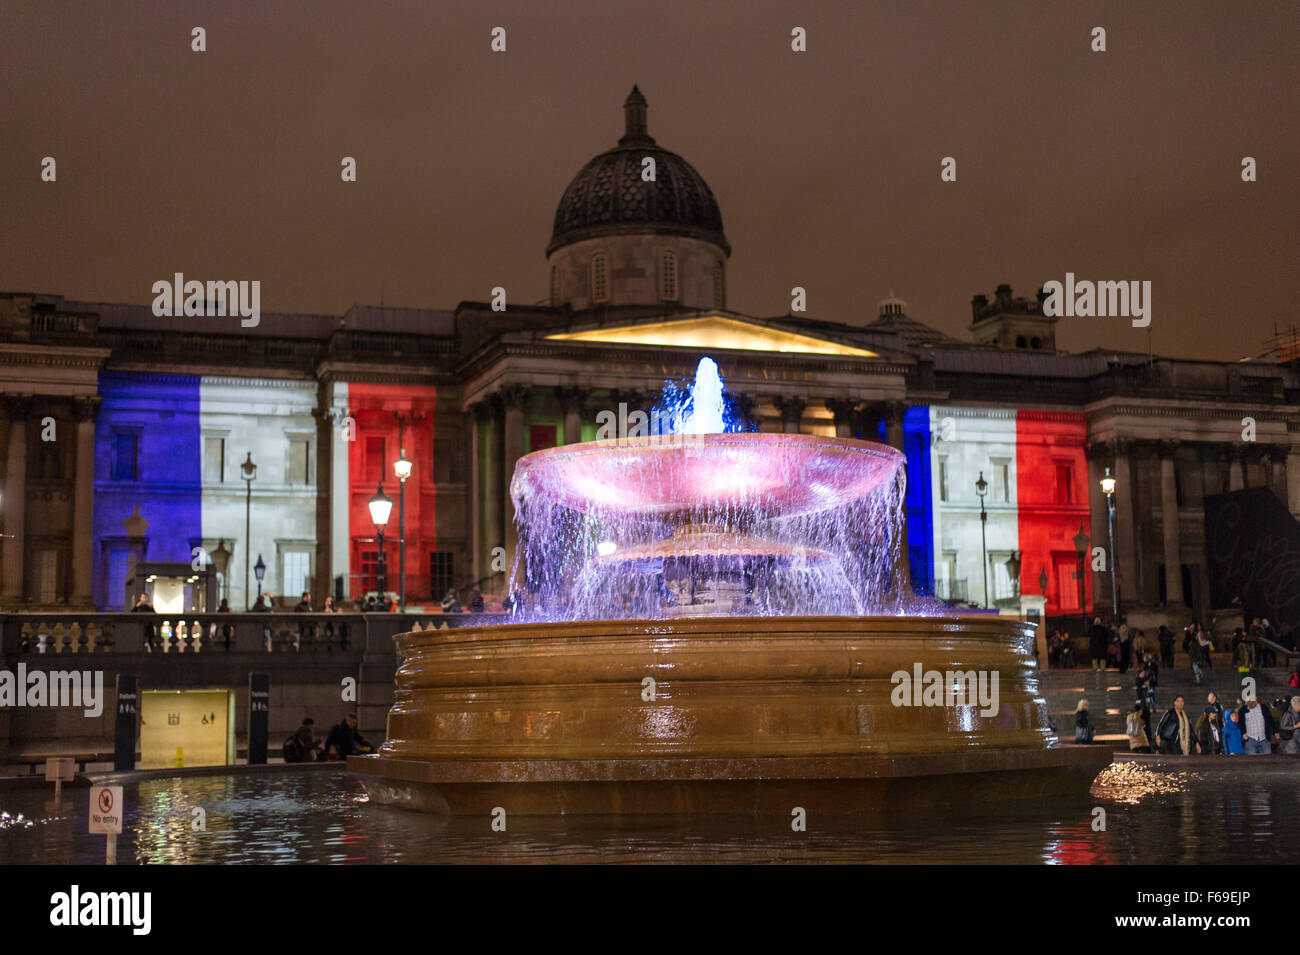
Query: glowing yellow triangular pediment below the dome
[{"left": 546, "top": 314, "right": 876, "bottom": 359}]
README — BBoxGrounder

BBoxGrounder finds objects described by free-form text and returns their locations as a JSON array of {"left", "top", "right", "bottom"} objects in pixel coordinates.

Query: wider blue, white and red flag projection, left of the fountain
[{"left": 94, "top": 372, "right": 438, "bottom": 609}]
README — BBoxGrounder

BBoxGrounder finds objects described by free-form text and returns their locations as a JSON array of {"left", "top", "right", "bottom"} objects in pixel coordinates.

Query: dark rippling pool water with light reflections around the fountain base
[{"left": 0, "top": 758, "right": 1300, "bottom": 864}]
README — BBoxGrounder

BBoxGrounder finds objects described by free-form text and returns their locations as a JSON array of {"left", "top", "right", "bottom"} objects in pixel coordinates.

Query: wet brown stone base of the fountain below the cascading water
[{"left": 348, "top": 616, "right": 1110, "bottom": 815}]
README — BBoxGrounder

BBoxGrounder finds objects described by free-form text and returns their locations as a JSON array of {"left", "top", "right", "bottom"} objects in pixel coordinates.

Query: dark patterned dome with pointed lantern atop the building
[{"left": 546, "top": 86, "right": 731, "bottom": 256}]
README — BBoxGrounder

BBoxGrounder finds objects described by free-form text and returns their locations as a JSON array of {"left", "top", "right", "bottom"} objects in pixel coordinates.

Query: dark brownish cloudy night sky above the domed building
[{"left": 0, "top": 0, "right": 1300, "bottom": 357}]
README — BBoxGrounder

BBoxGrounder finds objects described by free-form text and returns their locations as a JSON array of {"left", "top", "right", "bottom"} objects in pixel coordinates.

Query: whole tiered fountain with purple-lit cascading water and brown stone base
[{"left": 348, "top": 359, "right": 1109, "bottom": 815}]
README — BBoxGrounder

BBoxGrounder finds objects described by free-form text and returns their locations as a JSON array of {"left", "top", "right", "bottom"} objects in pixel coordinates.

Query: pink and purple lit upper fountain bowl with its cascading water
[{"left": 511, "top": 357, "right": 946, "bottom": 621}]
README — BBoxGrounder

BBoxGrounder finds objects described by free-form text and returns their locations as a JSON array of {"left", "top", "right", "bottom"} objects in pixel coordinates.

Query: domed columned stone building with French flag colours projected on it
[{"left": 0, "top": 88, "right": 1300, "bottom": 624}]
